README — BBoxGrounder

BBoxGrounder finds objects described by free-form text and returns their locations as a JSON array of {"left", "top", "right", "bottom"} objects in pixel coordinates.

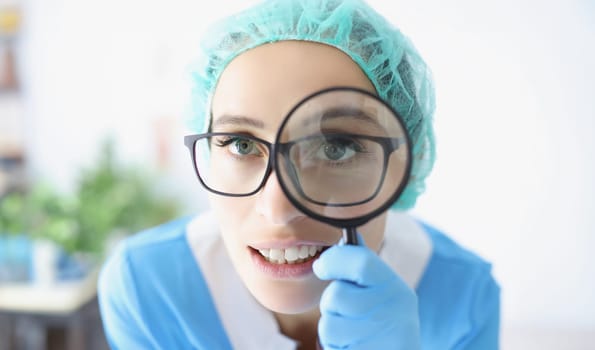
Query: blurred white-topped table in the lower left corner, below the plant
[{"left": 0, "top": 268, "right": 109, "bottom": 350}]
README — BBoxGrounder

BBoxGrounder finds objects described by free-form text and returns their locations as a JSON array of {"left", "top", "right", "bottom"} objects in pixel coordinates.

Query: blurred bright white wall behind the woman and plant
[{"left": 0, "top": 0, "right": 595, "bottom": 349}]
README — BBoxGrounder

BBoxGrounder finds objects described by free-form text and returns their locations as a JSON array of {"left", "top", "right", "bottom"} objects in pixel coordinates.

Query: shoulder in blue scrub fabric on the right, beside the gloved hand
[{"left": 417, "top": 222, "right": 500, "bottom": 349}]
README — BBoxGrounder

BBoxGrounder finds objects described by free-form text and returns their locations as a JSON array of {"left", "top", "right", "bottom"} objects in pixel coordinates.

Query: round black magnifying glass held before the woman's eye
[{"left": 272, "top": 87, "right": 412, "bottom": 244}]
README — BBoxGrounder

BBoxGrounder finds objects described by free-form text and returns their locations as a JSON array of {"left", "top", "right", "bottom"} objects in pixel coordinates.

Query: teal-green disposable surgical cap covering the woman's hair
[{"left": 189, "top": 0, "right": 435, "bottom": 210}]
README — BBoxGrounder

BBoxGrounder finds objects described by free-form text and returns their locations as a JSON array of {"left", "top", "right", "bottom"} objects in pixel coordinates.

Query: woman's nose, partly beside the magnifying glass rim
[{"left": 256, "top": 171, "right": 304, "bottom": 225}]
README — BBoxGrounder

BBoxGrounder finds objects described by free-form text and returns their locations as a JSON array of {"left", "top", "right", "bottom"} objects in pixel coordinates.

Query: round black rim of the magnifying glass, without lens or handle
[{"left": 272, "top": 86, "right": 413, "bottom": 228}]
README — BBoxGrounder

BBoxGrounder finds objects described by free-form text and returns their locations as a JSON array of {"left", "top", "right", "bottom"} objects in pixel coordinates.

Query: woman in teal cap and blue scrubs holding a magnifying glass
[{"left": 99, "top": 0, "right": 499, "bottom": 349}]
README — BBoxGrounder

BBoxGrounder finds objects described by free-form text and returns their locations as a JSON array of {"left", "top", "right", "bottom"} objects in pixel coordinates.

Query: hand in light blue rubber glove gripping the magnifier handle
[{"left": 313, "top": 235, "right": 421, "bottom": 350}]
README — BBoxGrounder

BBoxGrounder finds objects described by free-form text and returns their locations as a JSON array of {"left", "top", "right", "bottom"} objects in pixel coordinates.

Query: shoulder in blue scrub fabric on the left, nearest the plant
[{"left": 98, "top": 218, "right": 227, "bottom": 348}]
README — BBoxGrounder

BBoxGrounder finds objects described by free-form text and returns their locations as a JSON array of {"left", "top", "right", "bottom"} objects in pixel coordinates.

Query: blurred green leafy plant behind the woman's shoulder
[{"left": 0, "top": 139, "right": 179, "bottom": 254}]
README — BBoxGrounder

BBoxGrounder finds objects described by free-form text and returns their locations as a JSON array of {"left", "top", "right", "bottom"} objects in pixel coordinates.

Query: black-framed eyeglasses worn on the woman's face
[{"left": 184, "top": 132, "right": 406, "bottom": 206}]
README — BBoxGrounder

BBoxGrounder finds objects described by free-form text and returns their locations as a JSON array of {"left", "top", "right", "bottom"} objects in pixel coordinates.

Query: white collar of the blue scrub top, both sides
[{"left": 186, "top": 212, "right": 432, "bottom": 350}]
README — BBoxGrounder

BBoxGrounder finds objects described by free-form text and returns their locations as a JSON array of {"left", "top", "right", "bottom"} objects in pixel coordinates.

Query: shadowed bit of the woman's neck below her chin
[{"left": 275, "top": 308, "right": 320, "bottom": 350}]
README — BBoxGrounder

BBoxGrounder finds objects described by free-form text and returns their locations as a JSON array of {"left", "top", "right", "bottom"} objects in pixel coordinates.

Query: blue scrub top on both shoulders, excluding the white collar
[{"left": 99, "top": 213, "right": 500, "bottom": 350}]
